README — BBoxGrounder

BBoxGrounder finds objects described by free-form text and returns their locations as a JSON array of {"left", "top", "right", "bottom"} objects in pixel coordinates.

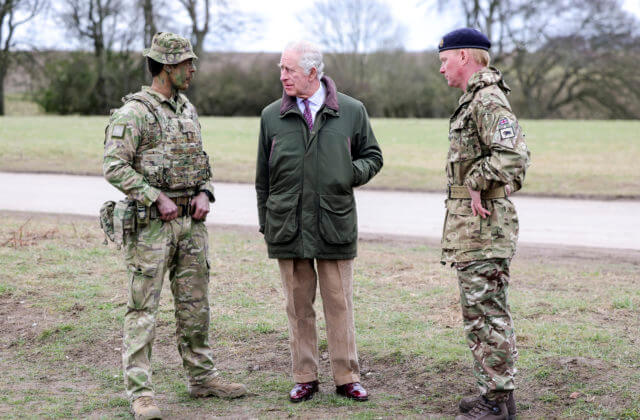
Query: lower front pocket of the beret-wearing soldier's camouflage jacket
[{"left": 442, "top": 199, "right": 491, "bottom": 250}]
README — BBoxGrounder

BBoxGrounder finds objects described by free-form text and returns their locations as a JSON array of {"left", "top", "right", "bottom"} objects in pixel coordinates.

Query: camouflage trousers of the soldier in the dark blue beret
[{"left": 455, "top": 258, "right": 518, "bottom": 400}]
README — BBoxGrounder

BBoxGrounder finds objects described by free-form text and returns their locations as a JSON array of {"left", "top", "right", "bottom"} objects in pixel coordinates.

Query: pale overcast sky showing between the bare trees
[{"left": 12, "top": 0, "right": 640, "bottom": 52}]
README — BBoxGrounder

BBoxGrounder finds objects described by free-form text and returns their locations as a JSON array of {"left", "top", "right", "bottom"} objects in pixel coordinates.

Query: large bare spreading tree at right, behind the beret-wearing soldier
[{"left": 437, "top": 0, "right": 640, "bottom": 118}]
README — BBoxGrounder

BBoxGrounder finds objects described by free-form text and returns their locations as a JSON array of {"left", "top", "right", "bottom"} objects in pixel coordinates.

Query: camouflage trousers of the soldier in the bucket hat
[{"left": 122, "top": 216, "right": 216, "bottom": 401}]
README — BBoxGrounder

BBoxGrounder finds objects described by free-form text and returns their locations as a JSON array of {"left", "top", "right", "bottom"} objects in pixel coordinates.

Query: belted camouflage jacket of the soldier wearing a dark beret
[{"left": 441, "top": 67, "right": 530, "bottom": 263}]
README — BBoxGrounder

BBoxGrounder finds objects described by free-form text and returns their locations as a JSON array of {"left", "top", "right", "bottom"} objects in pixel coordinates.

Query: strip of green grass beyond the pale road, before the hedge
[{"left": 0, "top": 116, "right": 640, "bottom": 198}]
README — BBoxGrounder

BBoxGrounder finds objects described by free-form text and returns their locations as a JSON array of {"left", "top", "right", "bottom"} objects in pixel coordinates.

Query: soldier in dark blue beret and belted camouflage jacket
[{"left": 439, "top": 28, "right": 530, "bottom": 420}]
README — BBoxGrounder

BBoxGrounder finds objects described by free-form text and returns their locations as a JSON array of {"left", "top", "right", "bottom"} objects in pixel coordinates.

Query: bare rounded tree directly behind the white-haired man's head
[{"left": 300, "top": 0, "right": 406, "bottom": 92}]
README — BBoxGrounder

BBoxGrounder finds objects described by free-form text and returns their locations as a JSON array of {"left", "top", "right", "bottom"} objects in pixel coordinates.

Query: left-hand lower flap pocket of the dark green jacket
[{"left": 264, "top": 193, "right": 300, "bottom": 244}]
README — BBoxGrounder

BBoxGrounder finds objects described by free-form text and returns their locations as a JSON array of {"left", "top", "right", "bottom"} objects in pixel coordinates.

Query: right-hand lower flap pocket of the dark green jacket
[{"left": 319, "top": 194, "right": 358, "bottom": 245}]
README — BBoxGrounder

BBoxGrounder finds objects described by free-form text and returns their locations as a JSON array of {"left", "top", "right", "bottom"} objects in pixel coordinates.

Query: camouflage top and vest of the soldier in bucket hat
[{"left": 103, "top": 87, "right": 213, "bottom": 206}]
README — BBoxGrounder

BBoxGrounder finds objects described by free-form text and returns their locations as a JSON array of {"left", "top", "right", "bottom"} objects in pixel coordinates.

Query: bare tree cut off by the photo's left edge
[{"left": 0, "top": 0, "right": 47, "bottom": 115}]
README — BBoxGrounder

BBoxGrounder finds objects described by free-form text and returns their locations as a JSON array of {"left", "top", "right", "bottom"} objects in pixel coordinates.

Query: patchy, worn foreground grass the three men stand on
[{"left": 0, "top": 212, "right": 640, "bottom": 419}]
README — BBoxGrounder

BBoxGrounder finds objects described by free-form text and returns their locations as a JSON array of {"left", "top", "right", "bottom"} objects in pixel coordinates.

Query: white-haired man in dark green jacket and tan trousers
[{"left": 256, "top": 42, "right": 382, "bottom": 402}]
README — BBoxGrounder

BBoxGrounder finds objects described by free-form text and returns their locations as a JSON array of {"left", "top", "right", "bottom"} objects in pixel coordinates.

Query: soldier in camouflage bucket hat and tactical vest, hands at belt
[{"left": 103, "top": 32, "right": 246, "bottom": 418}]
